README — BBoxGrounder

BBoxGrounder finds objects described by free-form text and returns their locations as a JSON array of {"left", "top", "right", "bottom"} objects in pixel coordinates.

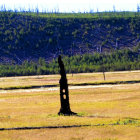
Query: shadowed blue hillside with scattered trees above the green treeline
[{"left": 0, "top": 11, "right": 140, "bottom": 64}]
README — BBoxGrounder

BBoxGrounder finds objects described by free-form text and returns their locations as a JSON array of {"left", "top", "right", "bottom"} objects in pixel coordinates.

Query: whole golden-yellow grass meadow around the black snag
[{"left": 0, "top": 71, "right": 140, "bottom": 140}]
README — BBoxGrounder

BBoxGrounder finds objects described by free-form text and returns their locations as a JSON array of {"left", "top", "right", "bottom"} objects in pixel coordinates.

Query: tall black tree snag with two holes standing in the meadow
[{"left": 58, "top": 55, "right": 76, "bottom": 115}]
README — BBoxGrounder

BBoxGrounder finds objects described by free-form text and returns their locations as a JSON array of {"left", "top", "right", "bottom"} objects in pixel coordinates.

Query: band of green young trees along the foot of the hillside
[{"left": 0, "top": 46, "right": 140, "bottom": 77}]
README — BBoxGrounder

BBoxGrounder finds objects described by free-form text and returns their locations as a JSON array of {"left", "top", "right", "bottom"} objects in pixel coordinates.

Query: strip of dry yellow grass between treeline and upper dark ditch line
[{"left": 0, "top": 71, "right": 140, "bottom": 88}]
